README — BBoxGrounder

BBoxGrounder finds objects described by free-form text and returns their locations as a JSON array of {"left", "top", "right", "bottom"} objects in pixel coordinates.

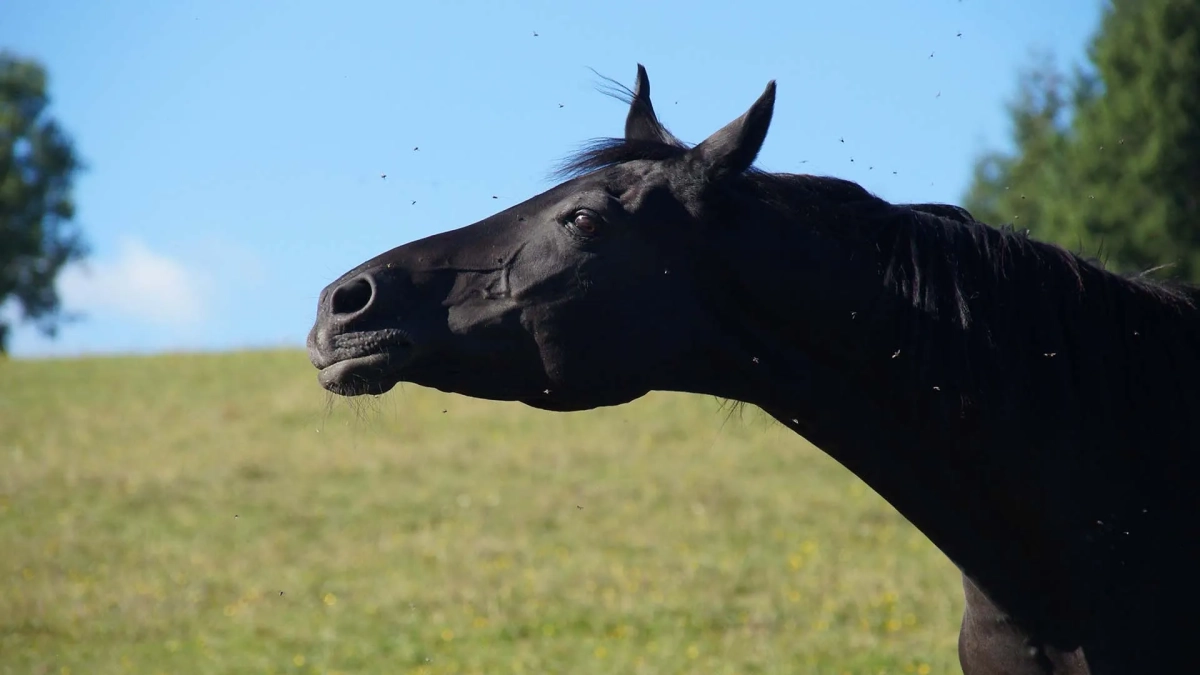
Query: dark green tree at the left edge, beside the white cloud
[{"left": 0, "top": 52, "right": 88, "bottom": 354}]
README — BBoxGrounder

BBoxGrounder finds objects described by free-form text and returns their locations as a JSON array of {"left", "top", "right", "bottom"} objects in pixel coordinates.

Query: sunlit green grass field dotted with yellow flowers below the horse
[{"left": 0, "top": 351, "right": 962, "bottom": 675}]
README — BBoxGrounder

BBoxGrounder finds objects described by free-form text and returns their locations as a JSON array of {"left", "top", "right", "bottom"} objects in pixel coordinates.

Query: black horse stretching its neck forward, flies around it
[{"left": 308, "top": 66, "right": 1200, "bottom": 675}]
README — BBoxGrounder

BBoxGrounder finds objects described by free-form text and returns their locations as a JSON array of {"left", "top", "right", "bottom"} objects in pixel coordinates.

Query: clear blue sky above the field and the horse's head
[{"left": 0, "top": 0, "right": 1100, "bottom": 357}]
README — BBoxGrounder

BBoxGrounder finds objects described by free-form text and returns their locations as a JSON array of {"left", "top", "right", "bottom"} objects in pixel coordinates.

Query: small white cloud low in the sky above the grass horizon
[{"left": 59, "top": 238, "right": 206, "bottom": 325}]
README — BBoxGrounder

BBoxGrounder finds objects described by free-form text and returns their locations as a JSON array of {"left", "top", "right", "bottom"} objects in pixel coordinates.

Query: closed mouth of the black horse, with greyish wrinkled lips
[{"left": 308, "top": 331, "right": 413, "bottom": 396}]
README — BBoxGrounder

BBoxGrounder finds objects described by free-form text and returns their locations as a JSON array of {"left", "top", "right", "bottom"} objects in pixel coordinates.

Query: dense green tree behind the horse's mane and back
[{"left": 964, "top": 0, "right": 1200, "bottom": 281}]
